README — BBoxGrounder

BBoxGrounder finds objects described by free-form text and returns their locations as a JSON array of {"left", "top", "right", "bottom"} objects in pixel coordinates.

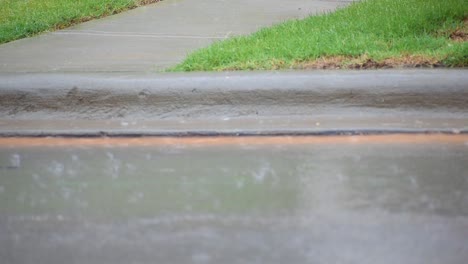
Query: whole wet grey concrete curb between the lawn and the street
[{"left": 0, "top": 69, "right": 468, "bottom": 136}]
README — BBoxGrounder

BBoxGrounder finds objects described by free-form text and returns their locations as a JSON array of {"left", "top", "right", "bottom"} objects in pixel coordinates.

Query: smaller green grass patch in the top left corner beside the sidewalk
[{"left": 0, "top": 0, "right": 157, "bottom": 43}]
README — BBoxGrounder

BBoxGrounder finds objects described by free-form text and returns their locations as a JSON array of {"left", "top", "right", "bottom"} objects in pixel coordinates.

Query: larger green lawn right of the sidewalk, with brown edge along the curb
[{"left": 169, "top": 0, "right": 468, "bottom": 71}]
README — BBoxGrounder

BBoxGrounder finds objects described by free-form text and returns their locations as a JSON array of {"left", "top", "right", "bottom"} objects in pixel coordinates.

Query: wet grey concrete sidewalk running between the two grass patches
[{"left": 0, "top": 0, "right": 352, "bottom": 73}]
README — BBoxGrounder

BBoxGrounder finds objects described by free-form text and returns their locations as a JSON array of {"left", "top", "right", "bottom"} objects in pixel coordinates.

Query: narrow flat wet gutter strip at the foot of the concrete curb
[{"left": 0, "top": 114, "right": 468, "bottom": 137}]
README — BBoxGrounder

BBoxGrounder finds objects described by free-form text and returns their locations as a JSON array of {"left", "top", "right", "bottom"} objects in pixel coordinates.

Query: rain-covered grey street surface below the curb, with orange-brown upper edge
[{"left": 0, "top": 134, "right": 468, "bottom": 264}]
